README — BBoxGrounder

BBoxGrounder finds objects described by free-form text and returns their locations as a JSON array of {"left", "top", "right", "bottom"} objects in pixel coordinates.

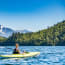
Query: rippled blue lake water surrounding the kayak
[{"left": 0, "top": 46, "right": 65, "bottom": 65}]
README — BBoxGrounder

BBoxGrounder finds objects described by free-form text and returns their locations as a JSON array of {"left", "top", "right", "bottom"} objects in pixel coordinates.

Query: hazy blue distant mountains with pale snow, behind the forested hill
[{"left": 0, "top": 25, "right": 31, "bottom": 37}]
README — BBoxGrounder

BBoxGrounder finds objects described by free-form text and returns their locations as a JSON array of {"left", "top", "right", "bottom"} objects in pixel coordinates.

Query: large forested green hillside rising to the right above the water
[{"left": 0, "top": 21, "right": 65, "bottom": 46}]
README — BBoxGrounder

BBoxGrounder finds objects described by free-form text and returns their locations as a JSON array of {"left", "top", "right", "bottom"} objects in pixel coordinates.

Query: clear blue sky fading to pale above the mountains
[{"left": 0, "top": 0, "right": 65, "bottom": 32}]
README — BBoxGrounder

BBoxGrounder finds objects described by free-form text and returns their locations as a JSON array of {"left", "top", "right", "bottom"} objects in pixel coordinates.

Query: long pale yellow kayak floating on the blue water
[{"left": 0, "top": 52, "right": 40, "bottom": 58}]
